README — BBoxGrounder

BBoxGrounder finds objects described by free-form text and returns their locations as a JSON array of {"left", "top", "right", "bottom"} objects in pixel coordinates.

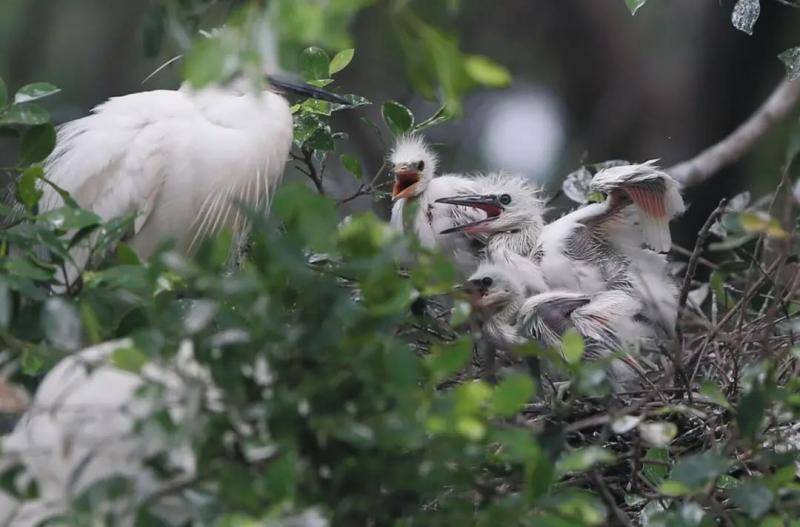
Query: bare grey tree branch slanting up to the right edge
[{"left": 667, "top": 80, "right": 800, "bottom": 187}]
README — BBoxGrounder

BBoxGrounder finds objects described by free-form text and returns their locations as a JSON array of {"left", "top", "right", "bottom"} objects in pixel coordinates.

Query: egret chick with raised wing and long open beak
[{"left": 439, "top": 163, "right": 683, "bottom": 334}]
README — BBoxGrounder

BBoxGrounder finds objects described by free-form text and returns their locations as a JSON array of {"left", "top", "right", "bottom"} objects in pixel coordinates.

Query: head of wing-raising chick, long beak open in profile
[{"left": 436, "top": 173, "right": 544, "bottom": 234}]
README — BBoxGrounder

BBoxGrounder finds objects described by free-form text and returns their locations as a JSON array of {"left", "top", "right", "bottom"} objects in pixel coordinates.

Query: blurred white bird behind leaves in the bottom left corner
[{"left": 0, "top": 339, "right": 219, "bottom": 527}]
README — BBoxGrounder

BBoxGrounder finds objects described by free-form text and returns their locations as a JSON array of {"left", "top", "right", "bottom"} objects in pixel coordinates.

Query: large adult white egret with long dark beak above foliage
[{"left": 40, "top": 77, "right": 348, "bottom": 280}]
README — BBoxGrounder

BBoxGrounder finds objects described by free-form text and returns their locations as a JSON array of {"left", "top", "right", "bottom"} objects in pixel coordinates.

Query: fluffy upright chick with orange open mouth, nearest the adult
[{"left": 389, "top": 135, "right": 490, "bottom": 274}]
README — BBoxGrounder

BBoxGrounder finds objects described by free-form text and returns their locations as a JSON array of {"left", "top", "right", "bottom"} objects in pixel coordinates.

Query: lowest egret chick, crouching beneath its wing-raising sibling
[{"left": 465, "top": 262, "right": 655, "bottom": 383}]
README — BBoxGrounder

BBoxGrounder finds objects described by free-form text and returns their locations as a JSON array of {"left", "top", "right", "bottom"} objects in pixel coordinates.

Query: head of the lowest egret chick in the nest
[{"left": 464, "top": 262, "right": 525, "bottom": 316}]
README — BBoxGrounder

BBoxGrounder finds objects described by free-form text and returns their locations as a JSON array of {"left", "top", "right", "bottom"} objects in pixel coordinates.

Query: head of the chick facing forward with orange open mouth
[{"left": 389, "top": 135, "right": 438, "bottom": 200}]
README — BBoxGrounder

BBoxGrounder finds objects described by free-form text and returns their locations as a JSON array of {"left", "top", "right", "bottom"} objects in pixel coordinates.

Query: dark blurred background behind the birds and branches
[{"left": 0, "top": 0, "right": 800, "bottom": 244}]
